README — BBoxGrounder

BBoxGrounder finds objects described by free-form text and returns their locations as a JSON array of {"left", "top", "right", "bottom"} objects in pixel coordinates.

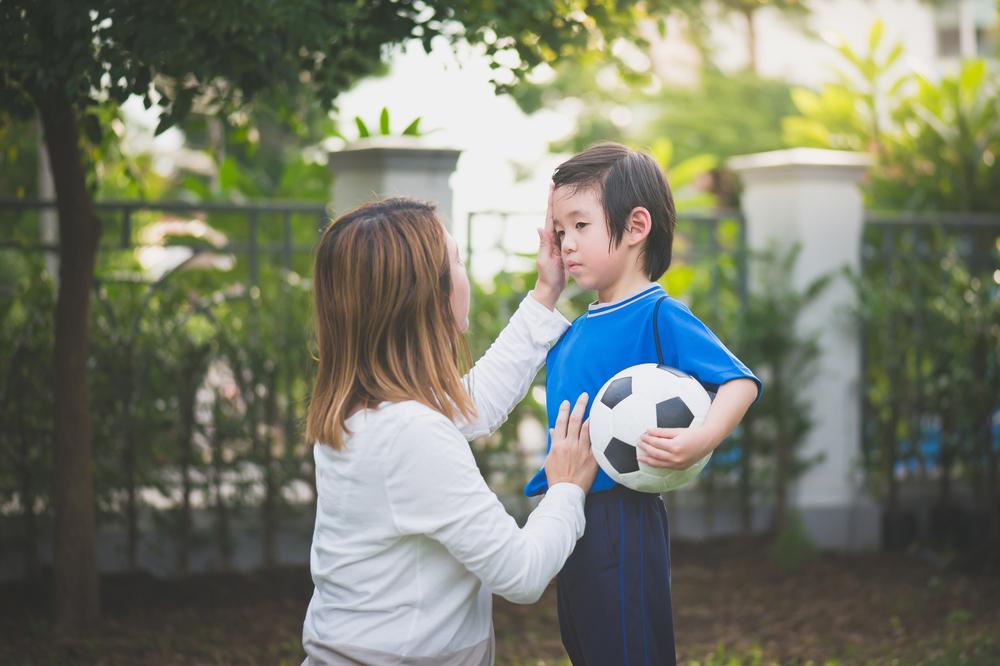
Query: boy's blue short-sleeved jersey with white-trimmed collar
[{"left": 524, "top": 284, "right": 761, "bottom": 495}]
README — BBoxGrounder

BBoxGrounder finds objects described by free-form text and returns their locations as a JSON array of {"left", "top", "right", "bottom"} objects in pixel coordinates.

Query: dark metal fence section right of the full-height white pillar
[{"left": 857, "top": 212, "right": 1000, "bottom": 545}]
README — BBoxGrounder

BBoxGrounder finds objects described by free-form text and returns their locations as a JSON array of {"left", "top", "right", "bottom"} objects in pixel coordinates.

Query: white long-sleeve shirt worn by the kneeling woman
[{"left": 303, "top": 296, "right": 584, "bottom": 666}]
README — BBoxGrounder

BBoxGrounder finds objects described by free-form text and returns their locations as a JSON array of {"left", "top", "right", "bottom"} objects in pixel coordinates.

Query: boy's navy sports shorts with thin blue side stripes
[{"left": 556, "top": 486, "right": 677, "bottom": 666}]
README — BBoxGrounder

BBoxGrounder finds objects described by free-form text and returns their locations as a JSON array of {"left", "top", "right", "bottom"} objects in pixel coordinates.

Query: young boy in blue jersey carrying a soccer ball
[{"left": 525, "top": 143, "right": 761, "bottom": 666}]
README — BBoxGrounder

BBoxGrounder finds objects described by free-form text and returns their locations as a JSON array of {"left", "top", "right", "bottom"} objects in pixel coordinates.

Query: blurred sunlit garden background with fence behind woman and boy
[{"left": 0, "top": 0, "right": 1000, "bottom": 666}]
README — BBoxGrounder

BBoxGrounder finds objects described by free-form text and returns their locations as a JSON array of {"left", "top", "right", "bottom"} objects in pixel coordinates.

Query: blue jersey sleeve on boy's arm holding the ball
[{"left": 657, "top": 298, "right": 763, "bottom": 402}]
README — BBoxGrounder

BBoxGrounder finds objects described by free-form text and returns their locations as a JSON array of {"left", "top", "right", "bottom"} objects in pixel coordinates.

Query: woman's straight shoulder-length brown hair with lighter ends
[{"left": 306, "top": 197, "right": 475, "bottom": 449}]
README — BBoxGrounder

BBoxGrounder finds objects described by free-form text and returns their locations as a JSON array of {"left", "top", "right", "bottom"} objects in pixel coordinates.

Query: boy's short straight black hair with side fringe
[{"left": 552, "top": 142, "right": 677, "bottom": 281}]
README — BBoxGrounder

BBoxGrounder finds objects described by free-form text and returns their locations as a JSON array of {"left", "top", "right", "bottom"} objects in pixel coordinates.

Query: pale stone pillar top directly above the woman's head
[{"left": 330, "top": 136, "right": 461, "bottom": 229}]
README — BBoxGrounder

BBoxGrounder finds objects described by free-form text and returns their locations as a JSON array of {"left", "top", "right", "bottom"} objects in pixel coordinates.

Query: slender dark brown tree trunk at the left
[{"left": 39, "top": 98, "right": 101, "bottom": 638}]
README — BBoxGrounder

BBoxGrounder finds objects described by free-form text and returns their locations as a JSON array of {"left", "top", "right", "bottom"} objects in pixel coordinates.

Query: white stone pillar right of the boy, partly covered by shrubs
[{"left": 729, "top": 148, "right": 879, "bottom": 549}]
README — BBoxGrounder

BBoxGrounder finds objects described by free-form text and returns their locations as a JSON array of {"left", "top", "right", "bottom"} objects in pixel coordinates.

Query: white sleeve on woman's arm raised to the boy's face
[{"left": 455, "top": 294, "right": 569, "bottom": 440}]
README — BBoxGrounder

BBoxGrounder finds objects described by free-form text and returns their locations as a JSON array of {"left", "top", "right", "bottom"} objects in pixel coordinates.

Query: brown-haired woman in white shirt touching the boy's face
[{"left": 303, "top": 198, "right": 597, "bottom": 665}]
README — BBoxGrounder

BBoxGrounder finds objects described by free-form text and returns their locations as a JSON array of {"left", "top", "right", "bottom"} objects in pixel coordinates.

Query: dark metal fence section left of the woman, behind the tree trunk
[{"left": 0, "top": 199, "right": 328, "bottom": 573}]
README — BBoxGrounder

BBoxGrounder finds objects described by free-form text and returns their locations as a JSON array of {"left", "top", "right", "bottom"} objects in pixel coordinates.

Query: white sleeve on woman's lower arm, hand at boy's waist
[{"left": 386, "top": 416, "right": 584, "bottom": 603}]
